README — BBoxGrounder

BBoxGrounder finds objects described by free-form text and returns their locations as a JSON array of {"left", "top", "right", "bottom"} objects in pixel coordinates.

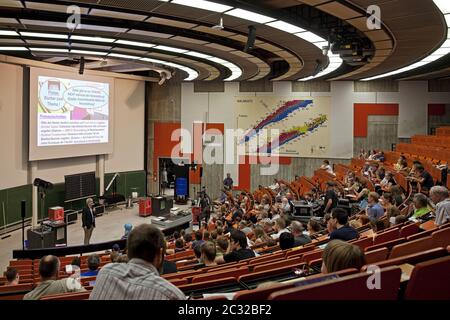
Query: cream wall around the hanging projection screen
[{"left": 0, "top": 63, "right": 145, "bottom": 190}]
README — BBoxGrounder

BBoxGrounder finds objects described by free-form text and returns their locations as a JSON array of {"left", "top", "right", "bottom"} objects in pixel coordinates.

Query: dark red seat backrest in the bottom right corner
[{"left": 404, "top": 256, "right": 450, "bottom": 300}]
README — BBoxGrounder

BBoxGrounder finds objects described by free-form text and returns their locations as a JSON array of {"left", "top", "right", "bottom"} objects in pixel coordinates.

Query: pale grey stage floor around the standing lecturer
[{"left": 0, "top": 204, "right": 188, "bottom": 274}]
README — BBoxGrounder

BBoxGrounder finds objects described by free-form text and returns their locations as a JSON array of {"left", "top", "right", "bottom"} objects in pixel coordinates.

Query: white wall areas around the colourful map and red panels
[{"left": 181, "top": 81, "right": 450, "bottom": 184}]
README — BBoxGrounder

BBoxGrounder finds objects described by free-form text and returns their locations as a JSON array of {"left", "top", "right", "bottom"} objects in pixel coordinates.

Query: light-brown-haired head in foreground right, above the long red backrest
[{"left": 322, "top": 240, "right": 366, "bottom": 274}]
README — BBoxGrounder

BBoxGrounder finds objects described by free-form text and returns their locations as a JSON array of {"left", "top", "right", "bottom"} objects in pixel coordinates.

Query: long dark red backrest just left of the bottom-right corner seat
[{"left": 269, "top": 267, "right": 401, "bottom": 300}]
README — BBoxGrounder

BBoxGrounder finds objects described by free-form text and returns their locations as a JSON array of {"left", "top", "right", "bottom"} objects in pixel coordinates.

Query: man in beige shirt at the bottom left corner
[{"left": 23, "top": 256, "right": 86, "bottom": 300}]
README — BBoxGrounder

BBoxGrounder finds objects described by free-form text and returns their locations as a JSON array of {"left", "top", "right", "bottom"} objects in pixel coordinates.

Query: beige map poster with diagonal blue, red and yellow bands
[{"left": 234, "top": 96, "right": 330, "bottom": 157}]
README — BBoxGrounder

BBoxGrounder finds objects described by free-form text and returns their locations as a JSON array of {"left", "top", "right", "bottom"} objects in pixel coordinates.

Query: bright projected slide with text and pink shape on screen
[{"left": 37, "top": 76, "right": 110, "bottom": 147}]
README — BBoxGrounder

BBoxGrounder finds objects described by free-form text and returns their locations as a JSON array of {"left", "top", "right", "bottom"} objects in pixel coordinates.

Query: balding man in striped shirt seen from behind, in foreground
[{"left": 89, "top": 224, "right": 186, "bottom": 300}]
